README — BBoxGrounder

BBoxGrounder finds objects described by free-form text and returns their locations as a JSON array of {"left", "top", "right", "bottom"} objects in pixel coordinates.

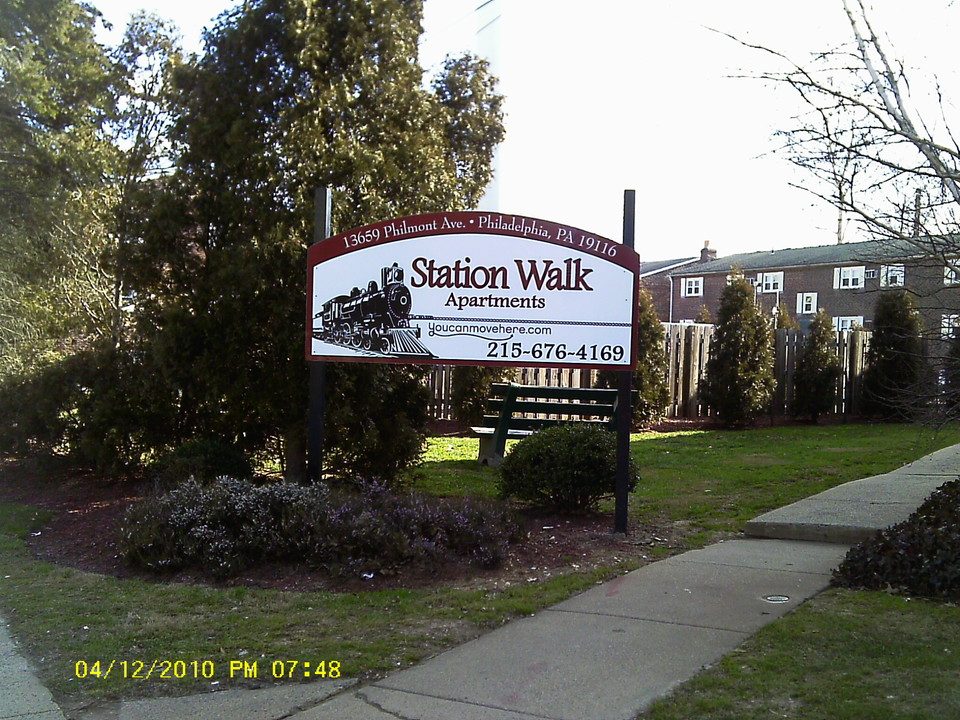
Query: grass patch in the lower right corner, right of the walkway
[{"left": 640, "top": 590, "right": 960, "bottom": 720}]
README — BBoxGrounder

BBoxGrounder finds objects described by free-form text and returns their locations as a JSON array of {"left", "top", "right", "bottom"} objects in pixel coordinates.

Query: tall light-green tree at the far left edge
[{"left": 0, "top": 0, "right": 116, "bottom": 376}]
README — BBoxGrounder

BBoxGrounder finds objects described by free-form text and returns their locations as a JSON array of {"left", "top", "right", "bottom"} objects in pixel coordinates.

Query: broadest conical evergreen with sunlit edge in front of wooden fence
[{"left": 703, "top": 272, "right": 775, "bottom": 427}]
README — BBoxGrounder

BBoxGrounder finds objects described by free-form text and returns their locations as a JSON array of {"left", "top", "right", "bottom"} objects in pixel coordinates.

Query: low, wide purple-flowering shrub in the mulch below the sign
[{"left": 121, "top": 478, "right": 520, "bottom": 579}]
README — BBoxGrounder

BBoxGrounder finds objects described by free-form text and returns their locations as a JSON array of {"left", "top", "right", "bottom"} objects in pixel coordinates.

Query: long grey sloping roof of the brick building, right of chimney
[{"left": 670, "top": 239, "right": 924, "bottom": 275}]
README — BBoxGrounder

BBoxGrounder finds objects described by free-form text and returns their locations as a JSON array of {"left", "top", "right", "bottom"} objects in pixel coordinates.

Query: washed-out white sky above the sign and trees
[{"left": 93, "top": 0, "right": 960, "bottom": 260}]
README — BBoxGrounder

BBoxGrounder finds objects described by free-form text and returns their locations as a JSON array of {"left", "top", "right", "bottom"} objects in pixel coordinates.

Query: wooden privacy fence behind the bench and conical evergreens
[{"left": 427, "top": 323, "right": 870, "bottom": 420}]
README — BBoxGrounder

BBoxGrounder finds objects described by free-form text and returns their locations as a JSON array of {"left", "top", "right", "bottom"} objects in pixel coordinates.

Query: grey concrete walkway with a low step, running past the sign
[{"left": 0, "top": 445, "right": 960, "bottom": 720}]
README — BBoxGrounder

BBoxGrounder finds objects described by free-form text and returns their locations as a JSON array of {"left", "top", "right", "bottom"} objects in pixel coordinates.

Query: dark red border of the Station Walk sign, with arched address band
[{"left": 306, "top": 210, "right": 640, "bottom": 370}]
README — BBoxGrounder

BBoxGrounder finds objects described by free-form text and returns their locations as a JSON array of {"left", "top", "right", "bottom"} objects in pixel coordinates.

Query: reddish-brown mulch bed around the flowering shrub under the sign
[{"left": 0, "top": 458, "right": 685, "bottom": 592}]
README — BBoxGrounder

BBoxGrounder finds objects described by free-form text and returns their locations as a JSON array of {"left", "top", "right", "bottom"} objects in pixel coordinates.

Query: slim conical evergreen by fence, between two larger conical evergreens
[{"left": 793, "top": 308, "right": 841, "bottom": 423}]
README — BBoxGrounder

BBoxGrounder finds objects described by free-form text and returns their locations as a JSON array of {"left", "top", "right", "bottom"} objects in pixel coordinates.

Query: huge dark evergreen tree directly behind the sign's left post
[{"left": 130, "top": 0, "right": 503, "bottom": 478}]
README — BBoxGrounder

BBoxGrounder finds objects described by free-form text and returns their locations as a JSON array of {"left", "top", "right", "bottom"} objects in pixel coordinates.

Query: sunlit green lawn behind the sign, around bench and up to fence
[{"left": 414, "top": 424, "right": 960, "bottom": 547}]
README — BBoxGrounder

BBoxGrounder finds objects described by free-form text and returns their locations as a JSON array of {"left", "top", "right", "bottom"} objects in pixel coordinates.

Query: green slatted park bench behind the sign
[{"left": 470, "top": 383, "right": 632, "bottom": 467}]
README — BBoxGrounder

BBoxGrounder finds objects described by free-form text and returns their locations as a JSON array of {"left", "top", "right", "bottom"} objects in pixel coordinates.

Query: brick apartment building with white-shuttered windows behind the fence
[{"left": 657, "top": 240, "right": 960, "bottom": 335}]
